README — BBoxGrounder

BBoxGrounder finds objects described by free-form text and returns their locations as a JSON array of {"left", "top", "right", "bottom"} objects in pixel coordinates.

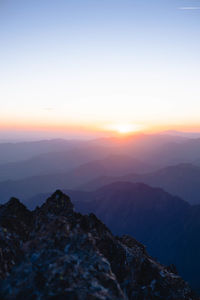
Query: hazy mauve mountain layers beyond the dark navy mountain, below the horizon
[{"left": 0, "top": 134, "right": 200, "bottom": 204}]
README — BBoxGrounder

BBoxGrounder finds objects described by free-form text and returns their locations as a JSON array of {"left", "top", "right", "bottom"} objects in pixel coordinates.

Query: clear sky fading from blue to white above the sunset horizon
[{"left": 0, "top": 0, "right": 200, "bottom": 137}]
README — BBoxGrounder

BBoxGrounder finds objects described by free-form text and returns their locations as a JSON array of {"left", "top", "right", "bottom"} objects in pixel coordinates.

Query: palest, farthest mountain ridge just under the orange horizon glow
[{"left": 0, "top": 134, "right": 182, "bottom": 164}]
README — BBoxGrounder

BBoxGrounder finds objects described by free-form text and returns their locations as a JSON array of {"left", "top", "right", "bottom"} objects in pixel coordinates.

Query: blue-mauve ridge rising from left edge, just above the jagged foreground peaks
[{"left": 0, "top": 155, "right": 153, "bottom": 202}]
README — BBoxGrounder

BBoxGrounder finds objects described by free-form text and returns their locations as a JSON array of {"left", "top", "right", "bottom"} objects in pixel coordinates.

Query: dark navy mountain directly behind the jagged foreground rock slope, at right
[{"left": 25, "top": 182, "right": 200, "bottom": 292}]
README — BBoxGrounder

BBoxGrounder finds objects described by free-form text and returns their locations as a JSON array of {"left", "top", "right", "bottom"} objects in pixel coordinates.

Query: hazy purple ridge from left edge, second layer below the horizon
[{"left": 0, "top": 145, "right": 109, "bottom": 181}]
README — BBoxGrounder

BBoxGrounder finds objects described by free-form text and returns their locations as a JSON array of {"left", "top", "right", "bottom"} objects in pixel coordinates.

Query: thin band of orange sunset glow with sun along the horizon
[{"left": 0, "top": 120, "right": 200, "bottom": 137}]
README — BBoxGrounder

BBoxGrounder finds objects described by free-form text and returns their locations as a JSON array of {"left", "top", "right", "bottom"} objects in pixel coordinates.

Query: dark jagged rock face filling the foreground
[{"left": 0, "top": 191, "right": 198, "bottom": 300}]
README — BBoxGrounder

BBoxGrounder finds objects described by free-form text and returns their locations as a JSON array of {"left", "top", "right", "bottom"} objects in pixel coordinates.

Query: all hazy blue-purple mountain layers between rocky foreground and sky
[{"left": 0, "top": 134, "right": 200, "bottom": 292}]
